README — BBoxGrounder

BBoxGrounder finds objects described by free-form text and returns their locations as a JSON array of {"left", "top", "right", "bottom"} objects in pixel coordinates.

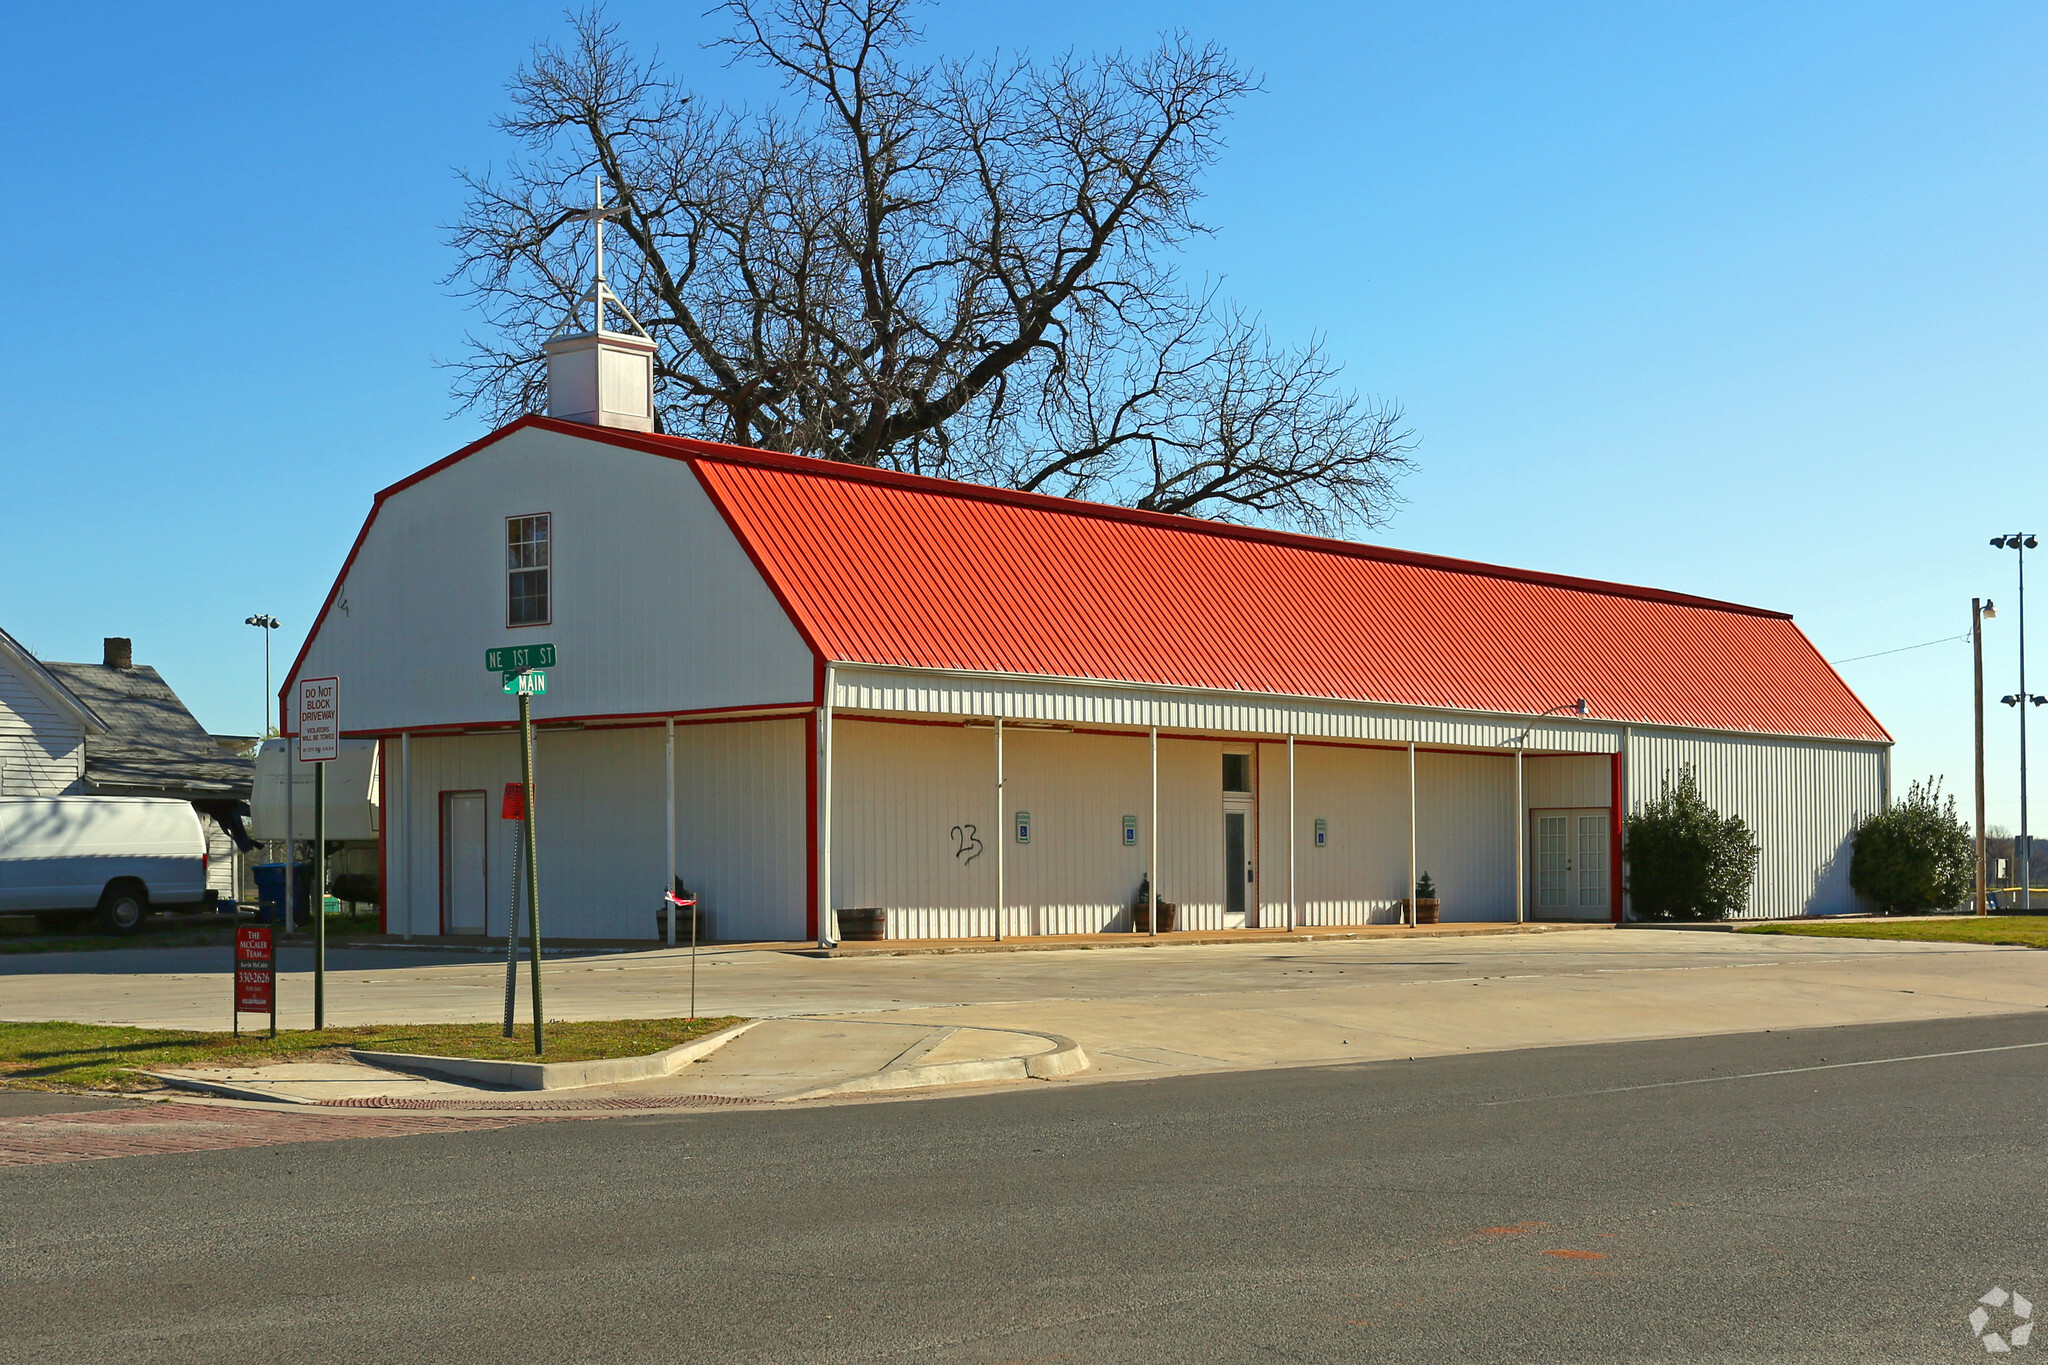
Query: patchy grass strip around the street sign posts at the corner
[{"left": 0, "top": 1017, "right": 739, "bottom": 1091}]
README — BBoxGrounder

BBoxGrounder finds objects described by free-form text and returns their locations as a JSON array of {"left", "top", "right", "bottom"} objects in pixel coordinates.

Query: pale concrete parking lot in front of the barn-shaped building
[{"left": 0, "top": 929, "right": 2048, "bottom": 1078}]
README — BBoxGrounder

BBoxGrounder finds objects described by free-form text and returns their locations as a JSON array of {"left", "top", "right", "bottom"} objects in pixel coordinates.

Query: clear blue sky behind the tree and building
[{"left": 0, "top": 0, "right": 2048, "bottom": 825}]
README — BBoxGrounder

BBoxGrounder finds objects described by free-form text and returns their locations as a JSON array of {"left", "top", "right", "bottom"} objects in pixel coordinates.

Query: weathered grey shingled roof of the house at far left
[{"left": 43, "top": 663, "right": 256, "bottom": 800}]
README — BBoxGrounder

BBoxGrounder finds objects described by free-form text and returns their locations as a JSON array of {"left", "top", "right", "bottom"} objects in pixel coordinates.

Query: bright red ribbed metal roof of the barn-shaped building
[{"left": 284, "top": 417, "right": 1890, "bottom": 741}]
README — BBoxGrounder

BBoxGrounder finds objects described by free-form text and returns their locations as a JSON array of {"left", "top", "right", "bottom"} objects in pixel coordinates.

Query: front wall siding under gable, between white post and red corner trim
[{"left": 671, "top": 720, "right": 811, "bottom": 941}]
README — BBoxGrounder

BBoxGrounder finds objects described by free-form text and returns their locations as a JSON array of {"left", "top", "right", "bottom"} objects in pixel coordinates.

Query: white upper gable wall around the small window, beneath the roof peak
[{"left": 287, "top": 430, "right": 813, "bottom": 740}]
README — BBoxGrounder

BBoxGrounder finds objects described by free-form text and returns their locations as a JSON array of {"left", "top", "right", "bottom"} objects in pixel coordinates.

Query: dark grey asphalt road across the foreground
[{"left": 0, "top": 1011, "right": 2048, "bottom": 1365}]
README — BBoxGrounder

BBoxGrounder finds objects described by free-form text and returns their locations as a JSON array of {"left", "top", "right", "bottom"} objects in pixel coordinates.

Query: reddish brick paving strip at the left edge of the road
[{"left": 0, "top": 1103, "right": 549, "bottom": 1166}]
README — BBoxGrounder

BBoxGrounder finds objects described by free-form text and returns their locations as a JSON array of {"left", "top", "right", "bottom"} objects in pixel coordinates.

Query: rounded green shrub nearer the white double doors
[{"left": 1622, "top": 763, "right": 1763, "bottom": 919}]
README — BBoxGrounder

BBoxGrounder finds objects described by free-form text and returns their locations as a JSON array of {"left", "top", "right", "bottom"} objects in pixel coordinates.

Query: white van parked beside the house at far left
[{"left": 0, "top": 796, "right": 207, "bottom": 933}]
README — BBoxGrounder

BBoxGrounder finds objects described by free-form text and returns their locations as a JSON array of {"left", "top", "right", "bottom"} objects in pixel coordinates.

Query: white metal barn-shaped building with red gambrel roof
[{"left": 283, "top": 362, "right": 1890, "bottom": 939}]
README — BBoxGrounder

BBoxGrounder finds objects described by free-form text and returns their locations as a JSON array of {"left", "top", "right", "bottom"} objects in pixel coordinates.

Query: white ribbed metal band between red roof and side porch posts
[{"left": 834, "top": 665, "right": 1620, "bottom": 753}]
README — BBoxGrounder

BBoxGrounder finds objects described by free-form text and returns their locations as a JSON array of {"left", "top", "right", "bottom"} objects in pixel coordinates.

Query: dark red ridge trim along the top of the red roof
[{"left": 528, "top": 415, "right": 1792, "bottom": 620}]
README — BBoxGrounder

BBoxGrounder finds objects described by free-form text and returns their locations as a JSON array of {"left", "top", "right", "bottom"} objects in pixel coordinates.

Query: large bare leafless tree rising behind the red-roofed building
[{"left": 451, "top": 0, "right": 1413, "bottom": 532}]
